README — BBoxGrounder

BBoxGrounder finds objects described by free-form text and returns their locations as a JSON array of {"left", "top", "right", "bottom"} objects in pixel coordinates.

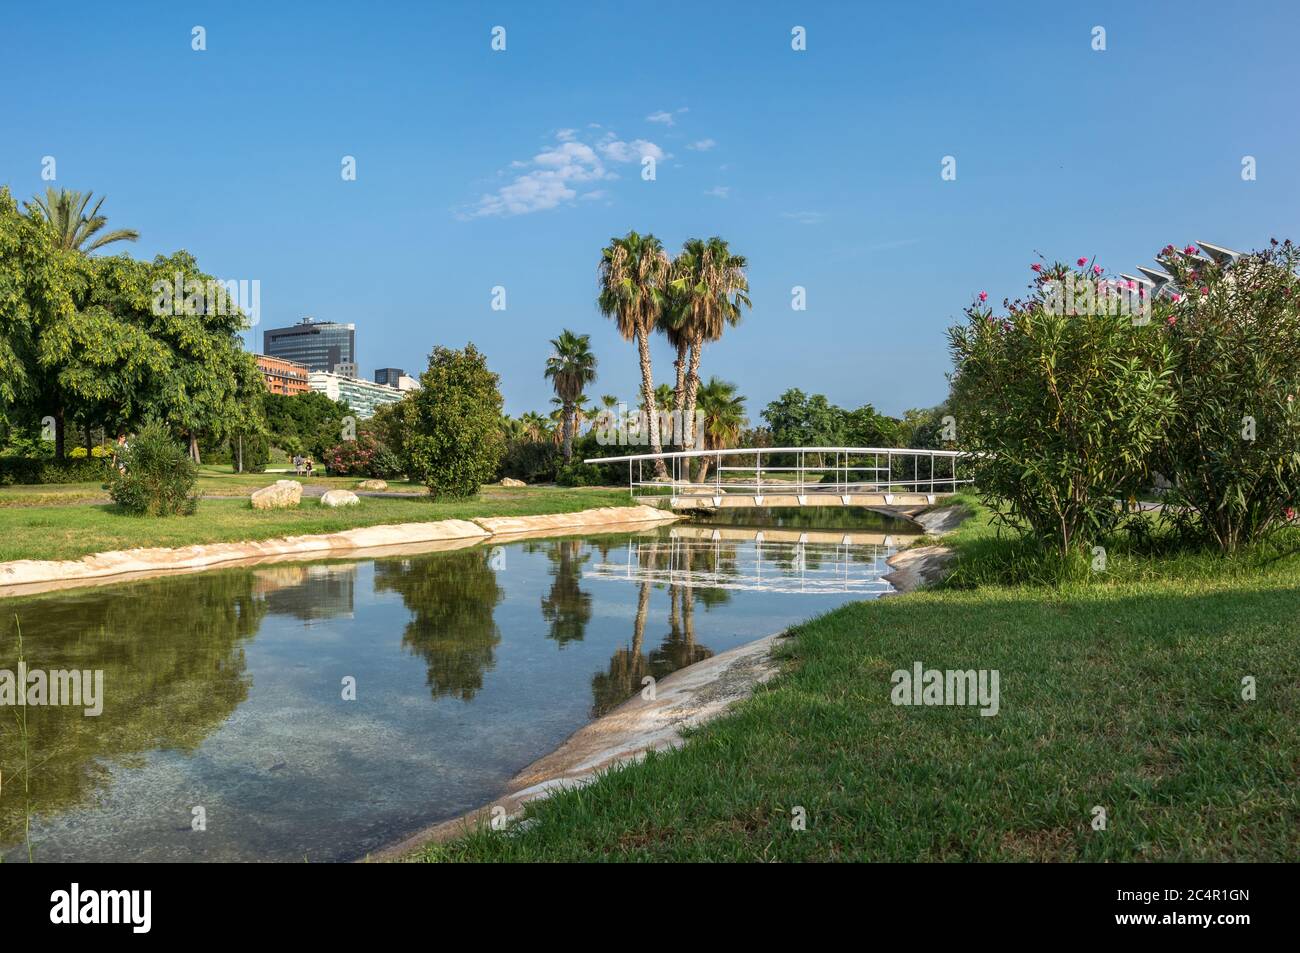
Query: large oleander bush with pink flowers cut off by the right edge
[{"left": 1160, "top": 241, "right": 1300, "bottom": 551}]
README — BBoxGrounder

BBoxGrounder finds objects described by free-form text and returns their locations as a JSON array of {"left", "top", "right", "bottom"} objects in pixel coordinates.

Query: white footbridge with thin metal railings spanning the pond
[{"left": 585, "top": 447, "right": 971, "bottom": 498}]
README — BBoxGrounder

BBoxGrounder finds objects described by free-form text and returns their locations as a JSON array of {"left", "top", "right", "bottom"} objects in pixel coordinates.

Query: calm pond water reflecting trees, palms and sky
[{"left": 0, "top": 510, "right": 907, "bottom": 862}]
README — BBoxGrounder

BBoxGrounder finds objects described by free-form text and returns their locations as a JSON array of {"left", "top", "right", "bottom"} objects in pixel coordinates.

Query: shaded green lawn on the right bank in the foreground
[{"left": 417, "top": 494, "right": 1300, "bottom": 861}]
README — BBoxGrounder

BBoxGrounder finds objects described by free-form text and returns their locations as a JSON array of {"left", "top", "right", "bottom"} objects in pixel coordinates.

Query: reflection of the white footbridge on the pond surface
[{"left": 584, "top": 525, "right": 914, "bottom": 594}]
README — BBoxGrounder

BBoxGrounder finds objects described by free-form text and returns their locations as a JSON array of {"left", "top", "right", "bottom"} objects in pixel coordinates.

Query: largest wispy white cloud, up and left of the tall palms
[{"left": 458, "top": 129, "right": 668, "bottom": 218}]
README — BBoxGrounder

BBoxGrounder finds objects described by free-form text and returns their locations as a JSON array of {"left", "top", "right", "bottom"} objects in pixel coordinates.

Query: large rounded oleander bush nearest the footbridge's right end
[{"left": 948, "top": 265, "right": 1175, "bottom": 554}]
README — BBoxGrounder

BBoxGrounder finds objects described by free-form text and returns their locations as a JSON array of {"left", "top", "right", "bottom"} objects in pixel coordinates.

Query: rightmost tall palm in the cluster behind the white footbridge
[{"left": 672, "top": 235, "right": 750, "bottom": 446}]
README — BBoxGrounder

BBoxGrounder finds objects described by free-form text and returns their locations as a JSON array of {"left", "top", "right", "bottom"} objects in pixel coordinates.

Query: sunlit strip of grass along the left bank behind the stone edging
[{"left": 0, "top": 486, "right": 632, "bottom": 562}]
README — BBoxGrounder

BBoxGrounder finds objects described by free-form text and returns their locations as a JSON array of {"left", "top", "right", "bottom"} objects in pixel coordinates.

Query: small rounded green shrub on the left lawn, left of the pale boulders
[{"left": 108, "top": 420, "right": 199, "bottom": 516}]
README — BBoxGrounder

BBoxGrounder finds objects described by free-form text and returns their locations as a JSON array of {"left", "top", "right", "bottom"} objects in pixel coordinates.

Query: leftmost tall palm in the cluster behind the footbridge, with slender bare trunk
[{"left": 597, "top": 231, "right": 670, "bottom": 477}]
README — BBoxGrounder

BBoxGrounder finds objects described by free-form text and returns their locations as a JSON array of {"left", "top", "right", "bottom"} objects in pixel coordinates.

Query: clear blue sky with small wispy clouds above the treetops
[{"left": 0, "top": 0, "right": 1300, "bottom": 416}]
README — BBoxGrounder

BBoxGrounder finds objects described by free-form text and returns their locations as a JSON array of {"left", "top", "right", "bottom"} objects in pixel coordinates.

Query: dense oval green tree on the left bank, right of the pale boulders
[{"left": 406, "top": 345, "right": 504, "bottom": 499}]
